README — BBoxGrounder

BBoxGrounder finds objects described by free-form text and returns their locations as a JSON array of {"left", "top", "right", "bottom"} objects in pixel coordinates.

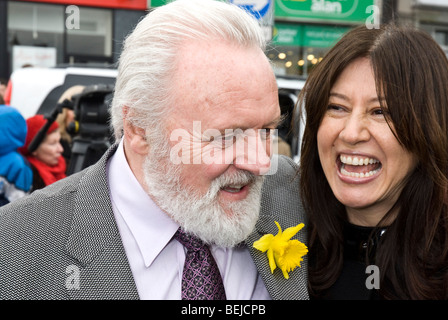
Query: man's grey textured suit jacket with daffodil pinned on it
[{"left": 0, "top": 146, "right": 308, "bottom": 299}]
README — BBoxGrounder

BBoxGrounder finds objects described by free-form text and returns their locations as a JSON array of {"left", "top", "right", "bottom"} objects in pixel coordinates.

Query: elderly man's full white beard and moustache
[{"left": 143, "top": 148, "right": 264, "bottom": 247}]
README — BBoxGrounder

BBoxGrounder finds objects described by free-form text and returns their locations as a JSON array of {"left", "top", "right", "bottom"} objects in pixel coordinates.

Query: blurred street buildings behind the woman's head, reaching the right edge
[{"left": 268, "top": 0, "right": 448, "bottom": 77}]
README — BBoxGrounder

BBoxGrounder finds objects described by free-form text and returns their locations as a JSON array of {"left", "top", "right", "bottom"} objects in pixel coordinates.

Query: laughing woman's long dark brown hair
[{"left": 297, "top": 25, "right": 448, "bottom": 299}]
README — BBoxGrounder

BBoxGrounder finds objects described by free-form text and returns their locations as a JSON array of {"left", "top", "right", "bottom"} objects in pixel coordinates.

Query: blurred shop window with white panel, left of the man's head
[{"left": 8, "top": 1, "right": 113, "bottom": 71}]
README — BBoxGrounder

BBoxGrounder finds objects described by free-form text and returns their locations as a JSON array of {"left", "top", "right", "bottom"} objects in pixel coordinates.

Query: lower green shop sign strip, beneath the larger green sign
[{"left": 272, "top": 23, "right": 350, "bottom": 48}]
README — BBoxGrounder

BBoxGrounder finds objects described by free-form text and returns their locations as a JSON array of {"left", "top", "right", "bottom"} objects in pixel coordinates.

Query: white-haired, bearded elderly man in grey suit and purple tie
[{"left": 0, "top": 0, "right": 308, "bottom": 299}]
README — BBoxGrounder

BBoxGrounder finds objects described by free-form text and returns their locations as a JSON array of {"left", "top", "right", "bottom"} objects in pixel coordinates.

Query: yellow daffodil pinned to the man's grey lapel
[{"left": 253, "top": 221, "right": 308, "bottom": 279}]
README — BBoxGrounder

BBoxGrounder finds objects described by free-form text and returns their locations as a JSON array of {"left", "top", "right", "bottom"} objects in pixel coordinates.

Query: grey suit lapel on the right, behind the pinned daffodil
[{"left": 246, "top": 158, "right": 309, "bottom": 300}]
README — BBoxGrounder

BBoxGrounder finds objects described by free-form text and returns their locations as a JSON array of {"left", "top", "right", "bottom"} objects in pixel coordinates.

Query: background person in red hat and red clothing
[{"left": 19, "top": 115, "right": 66, "bottom": 191}]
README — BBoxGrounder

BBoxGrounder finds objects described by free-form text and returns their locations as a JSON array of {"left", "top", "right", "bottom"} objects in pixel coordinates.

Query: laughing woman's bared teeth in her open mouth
[{"left": 340, "top": 155, "right": 381, "bottom": 178}]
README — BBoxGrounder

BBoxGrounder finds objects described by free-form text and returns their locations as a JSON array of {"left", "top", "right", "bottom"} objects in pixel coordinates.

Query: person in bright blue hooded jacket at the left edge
[{"left": 0, "top": 105, "right": 33, "bottom": 206}]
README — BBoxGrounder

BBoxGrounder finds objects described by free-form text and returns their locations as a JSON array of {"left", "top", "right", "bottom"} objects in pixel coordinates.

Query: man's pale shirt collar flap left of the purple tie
[{"left": 108, "top": 139, "right": 179, "bottom": 267}]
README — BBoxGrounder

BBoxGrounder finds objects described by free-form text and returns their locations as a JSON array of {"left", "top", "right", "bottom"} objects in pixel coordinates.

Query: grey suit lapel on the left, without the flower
[{"left": 66, "top": 146, "right": 139, "bottom": 299}]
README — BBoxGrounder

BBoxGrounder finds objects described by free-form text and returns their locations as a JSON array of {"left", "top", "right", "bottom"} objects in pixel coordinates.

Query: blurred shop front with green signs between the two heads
[{"left": 267, "top": 0, "right": 379, "bottom": 77}]
